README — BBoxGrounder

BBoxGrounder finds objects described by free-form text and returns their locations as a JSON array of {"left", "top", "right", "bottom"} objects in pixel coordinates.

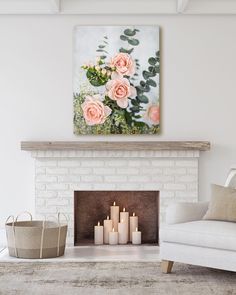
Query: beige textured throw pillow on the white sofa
[{"left": 203, "top": 184, "right": 236, "bottom": 222}]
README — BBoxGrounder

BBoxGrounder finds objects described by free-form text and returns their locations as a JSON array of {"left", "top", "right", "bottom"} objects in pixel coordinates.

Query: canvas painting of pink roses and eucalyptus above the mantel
[{"left": 73, "top": 26, "right": 160, "bottom": 135}]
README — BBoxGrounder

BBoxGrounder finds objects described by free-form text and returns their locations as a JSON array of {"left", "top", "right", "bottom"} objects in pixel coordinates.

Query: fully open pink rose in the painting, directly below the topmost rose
[{"left": 106, "top": 78, "right": 137, "bottom": 109}]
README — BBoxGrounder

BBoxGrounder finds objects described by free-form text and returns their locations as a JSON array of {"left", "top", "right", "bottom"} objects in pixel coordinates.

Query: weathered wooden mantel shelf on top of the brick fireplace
[{"left": 21, "top": 141, "right": 210, "bottom": 151}]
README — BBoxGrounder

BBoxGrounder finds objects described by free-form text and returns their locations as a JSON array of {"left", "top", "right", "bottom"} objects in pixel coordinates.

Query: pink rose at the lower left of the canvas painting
[{"left": 81, "top": 95, "right": 111, "bottom": 126}]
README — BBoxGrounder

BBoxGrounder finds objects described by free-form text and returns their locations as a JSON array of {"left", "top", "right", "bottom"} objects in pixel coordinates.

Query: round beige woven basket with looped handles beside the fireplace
[{"left": 5, "top": 212, "right": 67, "bottom": 259}]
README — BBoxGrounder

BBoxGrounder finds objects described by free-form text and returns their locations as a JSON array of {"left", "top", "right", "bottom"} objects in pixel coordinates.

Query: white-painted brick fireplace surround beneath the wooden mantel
[{"left": 23, "top": 148, "right": 206, "bottom": 244}]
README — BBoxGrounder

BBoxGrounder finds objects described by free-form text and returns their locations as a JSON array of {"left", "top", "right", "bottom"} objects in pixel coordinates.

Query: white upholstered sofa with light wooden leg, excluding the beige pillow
[{"left": 160, "top": 170, "right": 236, "bottom": 273}]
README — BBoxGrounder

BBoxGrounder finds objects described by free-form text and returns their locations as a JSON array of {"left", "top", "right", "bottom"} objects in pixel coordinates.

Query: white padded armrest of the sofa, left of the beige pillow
[{"left": 166, "top": 202, "right": 209, "bottom": 224}]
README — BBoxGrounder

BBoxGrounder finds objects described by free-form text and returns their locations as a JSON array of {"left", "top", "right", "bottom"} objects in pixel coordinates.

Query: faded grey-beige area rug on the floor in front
[{"left": 0, "top": 262, "right": 236, "bottom": 295}]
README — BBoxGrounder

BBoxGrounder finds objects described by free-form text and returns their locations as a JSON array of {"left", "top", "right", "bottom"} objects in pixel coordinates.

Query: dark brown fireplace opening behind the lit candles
[{"left": 74, "top": 191, "right": 159, "bottom": 246}]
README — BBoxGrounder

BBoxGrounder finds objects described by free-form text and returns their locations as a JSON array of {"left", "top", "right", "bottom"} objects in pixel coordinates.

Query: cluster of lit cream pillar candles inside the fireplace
[{"left": 94, "top": 202, "right": 141, "bottom": 245}]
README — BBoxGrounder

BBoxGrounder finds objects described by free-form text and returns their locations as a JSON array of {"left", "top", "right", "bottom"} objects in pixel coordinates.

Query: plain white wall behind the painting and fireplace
[{"left": 0, "top": 16, "right": 236, "bottom": 225}]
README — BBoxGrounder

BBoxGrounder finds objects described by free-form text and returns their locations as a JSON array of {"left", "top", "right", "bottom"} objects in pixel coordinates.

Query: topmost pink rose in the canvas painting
[{"left": 110, "top": 52, "right": 135, "bottom": 76}]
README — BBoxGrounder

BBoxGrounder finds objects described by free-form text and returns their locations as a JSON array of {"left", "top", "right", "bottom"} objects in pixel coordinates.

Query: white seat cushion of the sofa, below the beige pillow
[{"left": 160, "top": 220, "right": 236, "bottom": 251}]
